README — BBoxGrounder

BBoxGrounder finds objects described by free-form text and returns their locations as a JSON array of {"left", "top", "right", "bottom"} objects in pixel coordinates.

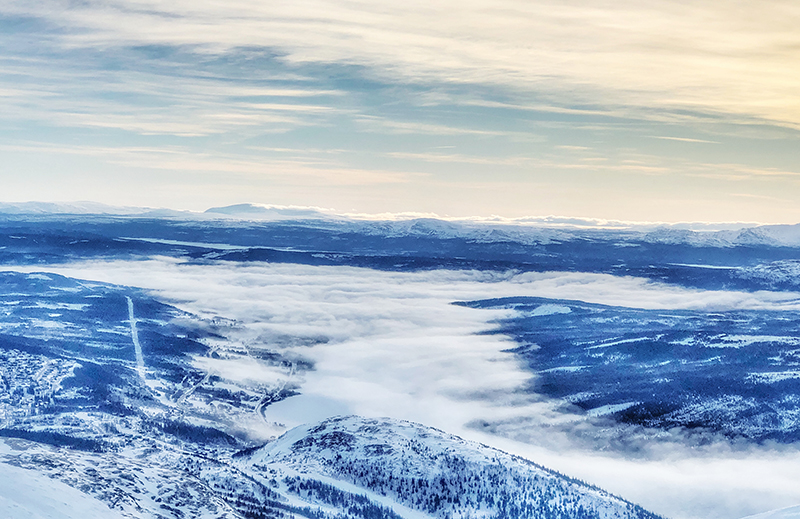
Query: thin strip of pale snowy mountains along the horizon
[{"left": 0, "top": 202, "right": 800, "bottom": 248}]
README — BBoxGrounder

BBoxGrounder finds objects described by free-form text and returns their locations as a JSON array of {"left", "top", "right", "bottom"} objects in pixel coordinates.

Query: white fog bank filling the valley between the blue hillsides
[{"left": 6, "top": 258, "right": 800, "bottom": 519}]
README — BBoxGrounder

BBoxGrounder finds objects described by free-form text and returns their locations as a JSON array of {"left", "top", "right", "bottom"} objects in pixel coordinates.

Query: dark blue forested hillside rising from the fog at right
[{"left": 458, "top": 297, "right": 800, "bottom": 442}]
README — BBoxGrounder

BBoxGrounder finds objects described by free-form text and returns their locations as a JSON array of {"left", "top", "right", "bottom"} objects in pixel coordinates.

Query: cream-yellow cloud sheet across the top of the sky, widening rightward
[{"left": 4, "top": 0, "right": 800, "bottom": 128}]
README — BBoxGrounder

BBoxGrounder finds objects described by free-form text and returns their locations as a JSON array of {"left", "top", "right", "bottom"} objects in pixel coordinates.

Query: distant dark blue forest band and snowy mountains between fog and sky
[{"left": 0, "top": 206, "right": 800, "bottom": 296}]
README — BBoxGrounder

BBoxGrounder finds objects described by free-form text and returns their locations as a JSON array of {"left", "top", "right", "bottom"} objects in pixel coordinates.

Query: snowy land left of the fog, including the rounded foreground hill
[{"left": 0, "top": 272, "right": 655, "bottom": 519}]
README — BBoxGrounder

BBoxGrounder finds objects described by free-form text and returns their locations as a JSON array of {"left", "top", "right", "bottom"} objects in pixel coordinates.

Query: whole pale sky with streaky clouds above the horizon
[{"left": 0, "top": 0, "right": 800, "bottom": 223}]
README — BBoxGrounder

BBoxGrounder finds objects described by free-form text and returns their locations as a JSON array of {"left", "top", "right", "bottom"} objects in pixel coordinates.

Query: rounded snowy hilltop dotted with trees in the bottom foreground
[{"left": 243, "top": 416, "right": 657, "bottom": 519}]
